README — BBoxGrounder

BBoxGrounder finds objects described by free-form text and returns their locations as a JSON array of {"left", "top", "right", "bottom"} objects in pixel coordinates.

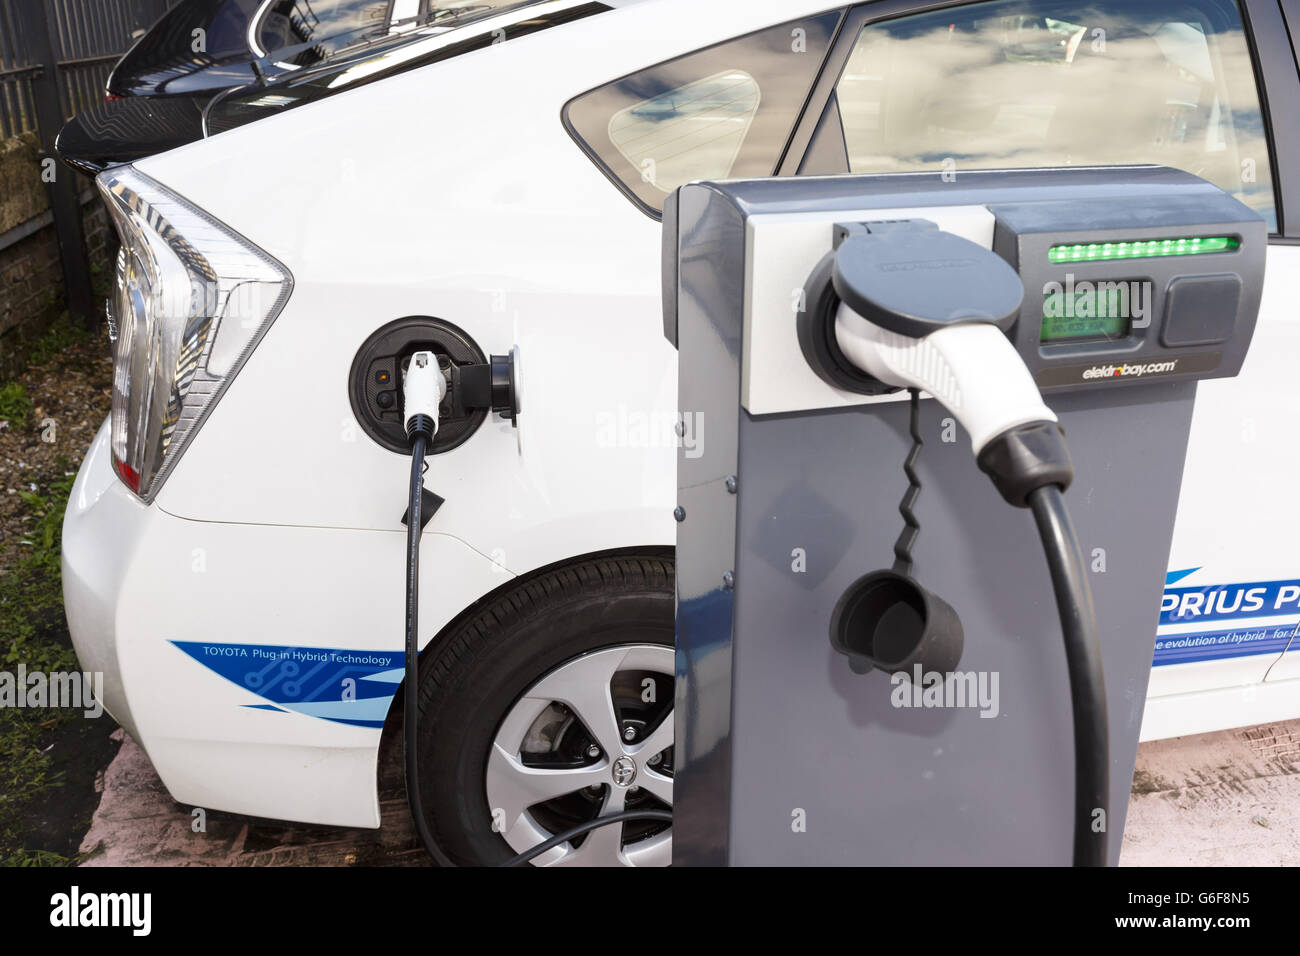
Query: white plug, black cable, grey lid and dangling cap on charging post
[{"left": 796, "top": 220, "right": 1110, "bottom": 866}]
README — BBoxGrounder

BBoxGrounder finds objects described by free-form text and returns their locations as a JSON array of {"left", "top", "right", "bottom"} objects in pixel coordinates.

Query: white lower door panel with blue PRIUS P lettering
[{"left": 1141, "top": 245, "right": 1300, "bottom": 740}]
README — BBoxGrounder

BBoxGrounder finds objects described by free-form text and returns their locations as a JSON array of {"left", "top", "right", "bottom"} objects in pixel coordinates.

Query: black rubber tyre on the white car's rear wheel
[{"left": 419, "top": 555, "right": 673, "bottom": 866}]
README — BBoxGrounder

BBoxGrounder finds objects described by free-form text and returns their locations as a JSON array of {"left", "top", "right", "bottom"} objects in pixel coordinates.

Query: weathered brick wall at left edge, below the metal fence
[{"left": 0, "top": 134, "right": 117, "bottom": 381}]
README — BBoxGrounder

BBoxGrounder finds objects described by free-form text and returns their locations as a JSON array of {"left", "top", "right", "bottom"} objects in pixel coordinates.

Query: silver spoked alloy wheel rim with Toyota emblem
[{"left": 485, "top": 644, "right": 673, "bottom": 866}]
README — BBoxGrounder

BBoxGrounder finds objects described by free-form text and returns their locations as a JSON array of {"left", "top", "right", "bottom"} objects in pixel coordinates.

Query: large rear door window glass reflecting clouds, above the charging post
[{"left": 815, "top": 0, "right": 1277, "bottom": 232}]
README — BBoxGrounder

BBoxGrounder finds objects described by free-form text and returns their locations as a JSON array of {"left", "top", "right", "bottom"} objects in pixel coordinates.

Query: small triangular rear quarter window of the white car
[{"left": 564, "top": 10, "right": 840, "bottom": 215}]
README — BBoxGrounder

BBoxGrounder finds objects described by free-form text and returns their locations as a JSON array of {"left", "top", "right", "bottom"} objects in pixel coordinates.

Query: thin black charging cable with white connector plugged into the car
[{"left": 402, "top": 351, "right": 672, "bottom": 866}]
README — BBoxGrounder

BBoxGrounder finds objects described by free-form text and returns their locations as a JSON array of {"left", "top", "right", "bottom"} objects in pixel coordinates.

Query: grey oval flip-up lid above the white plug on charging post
[{"left": 831, "top": 222, "right": 1024, "bottom": 338}]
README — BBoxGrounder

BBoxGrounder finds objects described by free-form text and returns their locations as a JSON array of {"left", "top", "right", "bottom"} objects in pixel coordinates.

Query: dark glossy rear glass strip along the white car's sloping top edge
[{"left": 204, "top": 0, "right": 610, "bottom": 135}]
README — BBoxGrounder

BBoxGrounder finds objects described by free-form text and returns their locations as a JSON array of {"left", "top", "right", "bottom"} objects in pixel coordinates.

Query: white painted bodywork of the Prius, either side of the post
[{"left": 64, "top": 0, "right": 1300, "bottom": 826}]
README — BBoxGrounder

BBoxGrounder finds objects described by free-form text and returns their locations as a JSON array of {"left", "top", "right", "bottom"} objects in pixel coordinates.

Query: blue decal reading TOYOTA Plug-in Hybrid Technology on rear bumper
[{"left": 172, "top": 641, "right": 406, "bottom": 727}]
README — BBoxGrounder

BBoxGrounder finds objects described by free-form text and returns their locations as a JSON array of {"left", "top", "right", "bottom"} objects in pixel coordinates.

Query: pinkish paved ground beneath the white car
[{"left": 82, "top": 721, "right": 1300, "bottom": 866}]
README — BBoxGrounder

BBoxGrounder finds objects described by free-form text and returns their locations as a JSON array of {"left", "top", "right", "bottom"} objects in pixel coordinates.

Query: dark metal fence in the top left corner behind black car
[{"left": 0, "top": 0, "right": 178, "bottom": 138}]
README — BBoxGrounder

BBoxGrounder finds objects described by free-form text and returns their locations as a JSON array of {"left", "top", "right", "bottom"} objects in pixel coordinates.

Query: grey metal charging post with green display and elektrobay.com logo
[{"left": 664, "top": 166, "right": 1266, "bottom": 865}]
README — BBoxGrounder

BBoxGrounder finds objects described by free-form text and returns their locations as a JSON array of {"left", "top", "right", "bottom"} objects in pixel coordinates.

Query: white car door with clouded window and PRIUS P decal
[{"left": 780, "top": 0, "right": 1300, "bottom": 737}]
